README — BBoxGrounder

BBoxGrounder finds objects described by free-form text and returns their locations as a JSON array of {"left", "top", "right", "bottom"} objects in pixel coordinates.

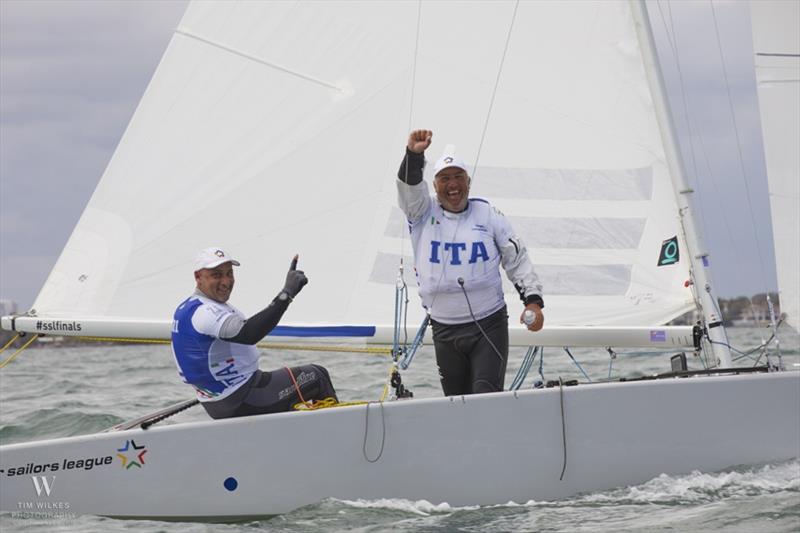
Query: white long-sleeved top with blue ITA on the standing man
[{"left": 397, "top": 151, "right": 544, "bottom": 324}]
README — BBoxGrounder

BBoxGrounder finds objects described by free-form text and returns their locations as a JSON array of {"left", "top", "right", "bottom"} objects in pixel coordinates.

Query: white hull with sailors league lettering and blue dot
[{"left": 0, "top": 372, "right": 800, "bottom": 520}]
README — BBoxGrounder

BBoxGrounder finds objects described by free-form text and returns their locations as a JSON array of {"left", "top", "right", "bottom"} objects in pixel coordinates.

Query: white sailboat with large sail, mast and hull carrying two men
[{"left": 0, "top": 1, "right": 800, "bottom": 520}]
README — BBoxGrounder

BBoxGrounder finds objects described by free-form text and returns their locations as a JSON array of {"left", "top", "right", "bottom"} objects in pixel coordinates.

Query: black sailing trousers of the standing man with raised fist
[{"left": 431, "top": 306, "right": 508, "bottom": 396}]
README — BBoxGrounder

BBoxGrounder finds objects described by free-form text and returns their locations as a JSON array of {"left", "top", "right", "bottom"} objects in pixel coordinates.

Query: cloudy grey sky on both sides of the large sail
[{"left": 0, "top": 0, "right": 777, "bottom": 312}]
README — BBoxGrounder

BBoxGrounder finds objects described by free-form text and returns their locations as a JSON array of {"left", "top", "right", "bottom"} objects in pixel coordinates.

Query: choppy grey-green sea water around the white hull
[{"left": 0, "top": 328, "right": 800, "bottom": 533}]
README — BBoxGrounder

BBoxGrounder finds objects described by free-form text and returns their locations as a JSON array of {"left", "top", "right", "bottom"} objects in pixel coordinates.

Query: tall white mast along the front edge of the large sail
[{"left": 631, "top": 0, "right": 733, "bottom": 368}]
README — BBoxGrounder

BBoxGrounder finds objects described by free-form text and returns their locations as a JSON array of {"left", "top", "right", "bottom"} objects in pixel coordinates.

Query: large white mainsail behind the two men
[{"left": 15, "top": 0, "right": 695, "bottom": 332}]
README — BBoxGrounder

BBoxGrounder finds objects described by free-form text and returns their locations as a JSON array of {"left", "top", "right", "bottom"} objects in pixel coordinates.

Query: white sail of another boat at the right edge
[{"left": 750, "top": 0, "right": 800, "bottom": 330}]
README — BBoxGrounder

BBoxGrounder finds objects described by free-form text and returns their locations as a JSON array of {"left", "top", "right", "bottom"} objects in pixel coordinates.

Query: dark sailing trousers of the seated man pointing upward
[{"left": 202, "top": 365, "right": 338, "bottom": 418}]
